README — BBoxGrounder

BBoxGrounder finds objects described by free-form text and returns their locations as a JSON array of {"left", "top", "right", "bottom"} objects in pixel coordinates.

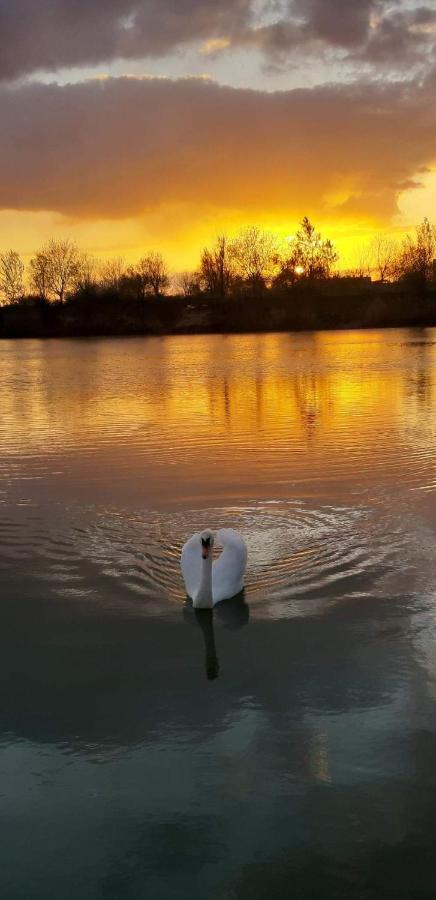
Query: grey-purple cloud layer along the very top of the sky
[{"left": 0, "top": 0, "right": 435, "bottom": 80}]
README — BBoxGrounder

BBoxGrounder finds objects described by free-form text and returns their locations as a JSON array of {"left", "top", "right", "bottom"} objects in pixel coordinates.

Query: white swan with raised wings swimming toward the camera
[{"left": 181, "top": 528, "right": 247, "bottom": 609}]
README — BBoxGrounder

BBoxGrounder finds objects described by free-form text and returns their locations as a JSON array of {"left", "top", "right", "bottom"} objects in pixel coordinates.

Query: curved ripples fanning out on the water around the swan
[{"left": 0, "top": 501, "right": 416, "bottom": 618}]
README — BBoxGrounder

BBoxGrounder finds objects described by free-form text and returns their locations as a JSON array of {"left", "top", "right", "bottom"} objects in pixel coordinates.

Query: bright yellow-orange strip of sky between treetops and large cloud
[{"left": 0, "top": 172, "right": 436, "bottom": 273}]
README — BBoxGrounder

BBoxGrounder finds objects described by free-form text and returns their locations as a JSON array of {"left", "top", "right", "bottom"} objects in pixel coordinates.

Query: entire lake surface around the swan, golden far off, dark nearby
[{"left": 0, "top": 330, "right": 436, "bottom": 900}]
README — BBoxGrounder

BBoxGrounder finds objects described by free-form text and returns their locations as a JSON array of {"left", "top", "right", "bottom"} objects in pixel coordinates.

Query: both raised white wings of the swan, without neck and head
[{"left": 181, "top": 528, "right": 247, "bottom": 604}]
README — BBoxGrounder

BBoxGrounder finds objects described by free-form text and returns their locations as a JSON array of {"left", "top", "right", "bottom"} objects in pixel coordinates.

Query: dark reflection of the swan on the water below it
[{"left": 183, "top": 591, "right": 250, "bottom": 681}]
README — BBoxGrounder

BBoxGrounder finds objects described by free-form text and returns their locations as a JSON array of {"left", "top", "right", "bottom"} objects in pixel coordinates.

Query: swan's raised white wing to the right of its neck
[{"left": 212, "top": 528, "right": 247, "bottom": 603}]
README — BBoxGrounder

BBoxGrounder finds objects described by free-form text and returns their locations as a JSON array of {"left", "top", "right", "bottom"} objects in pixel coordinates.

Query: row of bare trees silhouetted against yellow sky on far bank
[{"left": 0, "top": 216, "right": 436, "bottom": 305}]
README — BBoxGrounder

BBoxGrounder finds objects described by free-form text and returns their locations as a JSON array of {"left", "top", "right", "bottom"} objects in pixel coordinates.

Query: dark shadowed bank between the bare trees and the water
[{"left": 0, "top": 279, "right": 436, "bottom": 338}]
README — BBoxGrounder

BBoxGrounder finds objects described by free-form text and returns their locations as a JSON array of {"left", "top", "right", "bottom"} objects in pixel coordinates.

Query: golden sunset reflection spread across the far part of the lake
[{"left": 0, "top": 331, "right": 436, "bottom": 495}]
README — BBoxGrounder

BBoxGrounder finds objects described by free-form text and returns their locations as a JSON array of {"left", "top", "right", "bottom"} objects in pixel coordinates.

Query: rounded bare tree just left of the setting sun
[{"left": 229, "top": 226, "right": 279, "bottom": 291}]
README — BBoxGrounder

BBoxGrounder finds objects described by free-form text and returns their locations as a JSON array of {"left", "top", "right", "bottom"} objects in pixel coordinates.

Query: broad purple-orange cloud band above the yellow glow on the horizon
[{"left": 0, "top": 78, "right": 436, "bottom": 225}]
